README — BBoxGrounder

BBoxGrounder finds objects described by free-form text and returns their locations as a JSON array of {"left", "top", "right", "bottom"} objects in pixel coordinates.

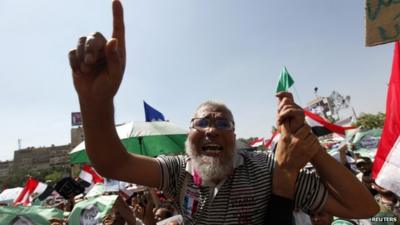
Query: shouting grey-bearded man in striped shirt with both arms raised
[{"left": 69, "top": 0, "right": 378, "bottom": 224}]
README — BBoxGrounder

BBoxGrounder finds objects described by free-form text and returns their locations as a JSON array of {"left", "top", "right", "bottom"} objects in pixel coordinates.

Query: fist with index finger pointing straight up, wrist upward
[{"left": 69, "top": 0, "right": 126, "bottom": 102}]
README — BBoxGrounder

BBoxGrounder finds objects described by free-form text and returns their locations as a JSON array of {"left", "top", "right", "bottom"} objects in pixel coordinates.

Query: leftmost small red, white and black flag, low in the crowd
[{"left": 14, "top": 177, "right": 54, "bottom": 206}]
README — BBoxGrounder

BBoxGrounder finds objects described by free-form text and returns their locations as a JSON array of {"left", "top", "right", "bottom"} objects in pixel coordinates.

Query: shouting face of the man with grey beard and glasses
[{"left": 186, "top": 106, "right": 236, "bottom": 185}]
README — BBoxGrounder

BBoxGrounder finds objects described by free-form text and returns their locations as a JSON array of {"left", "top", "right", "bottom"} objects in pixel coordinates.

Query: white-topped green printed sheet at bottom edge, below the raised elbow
[{"left": 68, "top": 195, "right": 118, "bottom": 225}]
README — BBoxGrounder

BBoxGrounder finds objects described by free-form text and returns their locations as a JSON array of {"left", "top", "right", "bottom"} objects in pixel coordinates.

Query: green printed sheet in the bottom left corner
[{"left": 0, "top": 206, "right": 63, "bottom": 225}]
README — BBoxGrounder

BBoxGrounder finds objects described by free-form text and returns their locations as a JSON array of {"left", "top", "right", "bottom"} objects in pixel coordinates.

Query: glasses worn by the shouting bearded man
[{"left": 190, "top": 117, "right": 235, "bottom": 131}]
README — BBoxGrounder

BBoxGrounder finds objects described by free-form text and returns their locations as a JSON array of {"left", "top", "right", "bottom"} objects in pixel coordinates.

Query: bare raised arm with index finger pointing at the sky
[{"left": 69, "top": 0, "right": 161, "bottom": 187}]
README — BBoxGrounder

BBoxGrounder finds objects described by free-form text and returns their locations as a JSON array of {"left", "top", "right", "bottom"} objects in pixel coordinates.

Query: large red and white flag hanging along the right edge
[{"left": 372, "top": 41, "right": 400, "bottom": 196}]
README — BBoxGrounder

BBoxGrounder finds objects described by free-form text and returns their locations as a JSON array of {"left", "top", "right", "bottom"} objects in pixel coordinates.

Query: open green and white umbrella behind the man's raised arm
[{"left": 69, "top": 121, "right": 187, "bottom": 164}]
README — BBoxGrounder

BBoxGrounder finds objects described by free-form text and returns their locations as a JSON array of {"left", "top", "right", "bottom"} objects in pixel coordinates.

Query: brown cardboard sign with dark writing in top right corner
[{"left": 365, "top": 0, "right": 400, "bottom": 46}]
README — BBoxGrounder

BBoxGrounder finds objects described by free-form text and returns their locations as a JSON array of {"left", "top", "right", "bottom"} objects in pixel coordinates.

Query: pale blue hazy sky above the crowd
[{"left": 0, "top": 0, "right": 394, "bottom": 161}]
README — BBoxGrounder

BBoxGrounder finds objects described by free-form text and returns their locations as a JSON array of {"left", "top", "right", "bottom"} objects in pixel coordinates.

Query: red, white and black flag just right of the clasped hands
[{"left": 304, "top": 110, "right": 356, "bottom": 137}]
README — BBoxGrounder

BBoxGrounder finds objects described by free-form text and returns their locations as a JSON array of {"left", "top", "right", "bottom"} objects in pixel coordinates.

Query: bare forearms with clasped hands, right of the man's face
[{"left": 273, "top": 92, "right": 379, "bottom": 218}]
